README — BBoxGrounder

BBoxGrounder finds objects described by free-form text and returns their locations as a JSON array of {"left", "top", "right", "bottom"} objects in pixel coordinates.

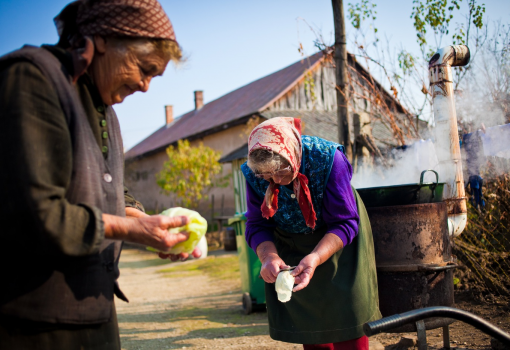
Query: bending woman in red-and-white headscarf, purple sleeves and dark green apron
[{"left": 241, "top": 118, "right": 381, "bottom": 350}]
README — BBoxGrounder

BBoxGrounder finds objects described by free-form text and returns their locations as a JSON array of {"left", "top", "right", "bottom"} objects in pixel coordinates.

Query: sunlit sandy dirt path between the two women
[{"left": 116, "top": 249, "right": 302, "bottom": 350}]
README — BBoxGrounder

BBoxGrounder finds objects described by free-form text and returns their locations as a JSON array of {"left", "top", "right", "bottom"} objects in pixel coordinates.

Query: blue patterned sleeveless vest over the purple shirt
[{"left": 241, "top": 136, "right": 345, "bottom": 234}]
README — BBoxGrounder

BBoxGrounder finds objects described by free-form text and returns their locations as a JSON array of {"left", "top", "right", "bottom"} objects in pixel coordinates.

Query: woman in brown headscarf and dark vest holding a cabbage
[{"left": 0, "top": 0, "right": 200, "bottom": 350}]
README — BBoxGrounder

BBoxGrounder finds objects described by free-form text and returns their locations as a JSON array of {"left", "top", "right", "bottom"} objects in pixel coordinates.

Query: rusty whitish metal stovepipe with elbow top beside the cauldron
[{"left": 429, "top": 45, "right": 470, "bottom": 237}]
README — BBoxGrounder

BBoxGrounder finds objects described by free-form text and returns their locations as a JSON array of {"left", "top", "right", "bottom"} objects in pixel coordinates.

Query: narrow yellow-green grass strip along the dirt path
[{"left": 158, "top": 255, "right": 239, "bottom": 279}]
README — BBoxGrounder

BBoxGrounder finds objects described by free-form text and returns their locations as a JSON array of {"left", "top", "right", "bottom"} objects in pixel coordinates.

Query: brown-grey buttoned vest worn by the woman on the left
[{"left": 0, "top": 46, "right": 125, "bottom": 324}]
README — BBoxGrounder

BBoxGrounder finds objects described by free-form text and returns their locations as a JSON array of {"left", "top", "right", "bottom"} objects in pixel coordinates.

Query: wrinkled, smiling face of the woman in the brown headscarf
[{"left": 89, "top": 36, "right": 168, "bottom": 105}]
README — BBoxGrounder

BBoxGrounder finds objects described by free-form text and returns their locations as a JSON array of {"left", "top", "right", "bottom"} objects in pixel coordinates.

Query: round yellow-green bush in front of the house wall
[{"left": 156, "top": 140, "right": 230, "bottom": 209}]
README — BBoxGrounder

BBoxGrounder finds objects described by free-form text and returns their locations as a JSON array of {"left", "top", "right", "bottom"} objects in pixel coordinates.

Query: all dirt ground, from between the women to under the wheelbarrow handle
[{"left": 116, "top": 249, "right": 510, "bottom": 350}]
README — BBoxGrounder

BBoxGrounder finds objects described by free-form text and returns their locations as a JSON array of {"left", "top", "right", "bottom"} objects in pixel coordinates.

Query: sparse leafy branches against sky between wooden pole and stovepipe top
[{"left": 340, "top": 0, "right": 487, "bottom": 136}]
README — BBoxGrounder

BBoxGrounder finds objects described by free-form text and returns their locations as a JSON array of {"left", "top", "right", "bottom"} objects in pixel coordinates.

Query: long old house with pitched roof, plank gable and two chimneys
[{"left": 125, "top": 52, "right": 418, "bottom": 217}]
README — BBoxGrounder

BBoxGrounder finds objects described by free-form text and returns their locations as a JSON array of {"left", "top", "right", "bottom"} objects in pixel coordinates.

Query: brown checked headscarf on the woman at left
[{"left": 55, "top": 0, "right": 177, "bottom": 42}]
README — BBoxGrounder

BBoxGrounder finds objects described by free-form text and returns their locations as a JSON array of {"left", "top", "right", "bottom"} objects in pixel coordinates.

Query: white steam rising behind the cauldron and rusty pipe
[{"left": 352, "top": 91, "right": 510, "bottom": 188}]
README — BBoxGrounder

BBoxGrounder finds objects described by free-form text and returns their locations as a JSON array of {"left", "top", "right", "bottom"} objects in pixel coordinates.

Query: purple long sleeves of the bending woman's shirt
[{"left": 245, "top": 150, "right": 359, "bottom": 251}]
